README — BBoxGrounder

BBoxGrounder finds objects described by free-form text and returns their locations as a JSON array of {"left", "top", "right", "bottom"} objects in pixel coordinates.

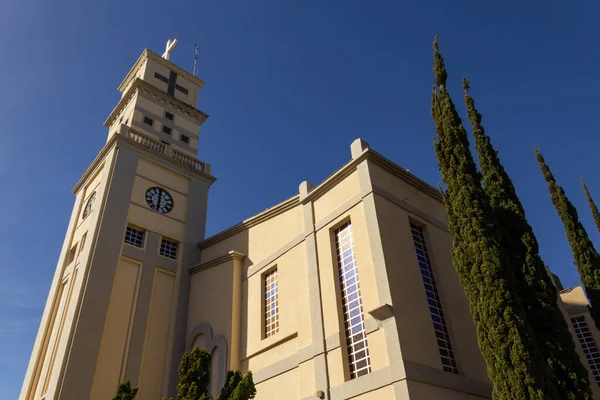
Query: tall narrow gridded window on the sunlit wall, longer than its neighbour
[{"left": 335, "top": 222, "right": 371, "bottom": 379}]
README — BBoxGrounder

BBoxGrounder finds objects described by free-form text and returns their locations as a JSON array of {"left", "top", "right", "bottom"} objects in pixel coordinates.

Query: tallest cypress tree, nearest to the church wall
[{"left": 432, "top": 38, "right": 558, "bottom": 399}]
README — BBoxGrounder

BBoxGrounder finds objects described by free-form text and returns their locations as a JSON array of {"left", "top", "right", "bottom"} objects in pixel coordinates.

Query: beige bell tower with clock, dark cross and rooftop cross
[{"left": 19, "top": 40, "right": 215, "bottom": 400}]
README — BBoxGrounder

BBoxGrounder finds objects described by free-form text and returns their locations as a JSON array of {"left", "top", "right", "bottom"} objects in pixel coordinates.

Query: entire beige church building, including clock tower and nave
[{"left": 20, "top": 44, "right": 600, "bottom": 400}]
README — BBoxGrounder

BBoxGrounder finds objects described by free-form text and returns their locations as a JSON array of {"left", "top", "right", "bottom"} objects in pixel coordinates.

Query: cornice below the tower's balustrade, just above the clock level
[{"left": 73, "top": 134, "right": 217, "bottom": 194}]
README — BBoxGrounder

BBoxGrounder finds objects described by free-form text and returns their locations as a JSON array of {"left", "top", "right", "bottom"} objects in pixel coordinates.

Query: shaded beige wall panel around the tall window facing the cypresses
[{"left": 375, "top": 195, "right": 488, "bottom": 381}]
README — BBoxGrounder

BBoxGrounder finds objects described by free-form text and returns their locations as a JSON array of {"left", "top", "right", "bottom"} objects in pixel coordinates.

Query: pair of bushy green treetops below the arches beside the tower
[{"left": 165, "top": 347, "right": 256, "bottom": 400}]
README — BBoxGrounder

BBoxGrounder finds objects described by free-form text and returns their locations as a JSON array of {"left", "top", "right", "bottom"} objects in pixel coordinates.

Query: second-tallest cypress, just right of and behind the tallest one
[{"left": 463, "top": 78, "right": 592, "bottom": 400}]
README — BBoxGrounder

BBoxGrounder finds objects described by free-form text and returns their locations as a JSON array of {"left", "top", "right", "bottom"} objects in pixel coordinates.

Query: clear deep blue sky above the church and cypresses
[{"left": 0, "top": 0, "right": 600, "bottom": 399}]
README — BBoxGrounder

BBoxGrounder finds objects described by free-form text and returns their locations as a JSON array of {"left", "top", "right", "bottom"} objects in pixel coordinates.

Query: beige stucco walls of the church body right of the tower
[{"left": 193, "top": 148, "right": 489, "bottom": 399}]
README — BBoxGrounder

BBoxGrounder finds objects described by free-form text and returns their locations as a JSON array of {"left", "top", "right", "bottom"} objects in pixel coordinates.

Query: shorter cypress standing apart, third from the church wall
[{"left": 535, "top": 147, "right": 600, "bottom": 329}]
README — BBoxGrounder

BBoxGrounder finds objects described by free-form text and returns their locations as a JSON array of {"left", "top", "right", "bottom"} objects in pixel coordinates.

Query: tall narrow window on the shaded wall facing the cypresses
[{"left": 410, "top": 223, "right": 458, "bottom": 374}]
